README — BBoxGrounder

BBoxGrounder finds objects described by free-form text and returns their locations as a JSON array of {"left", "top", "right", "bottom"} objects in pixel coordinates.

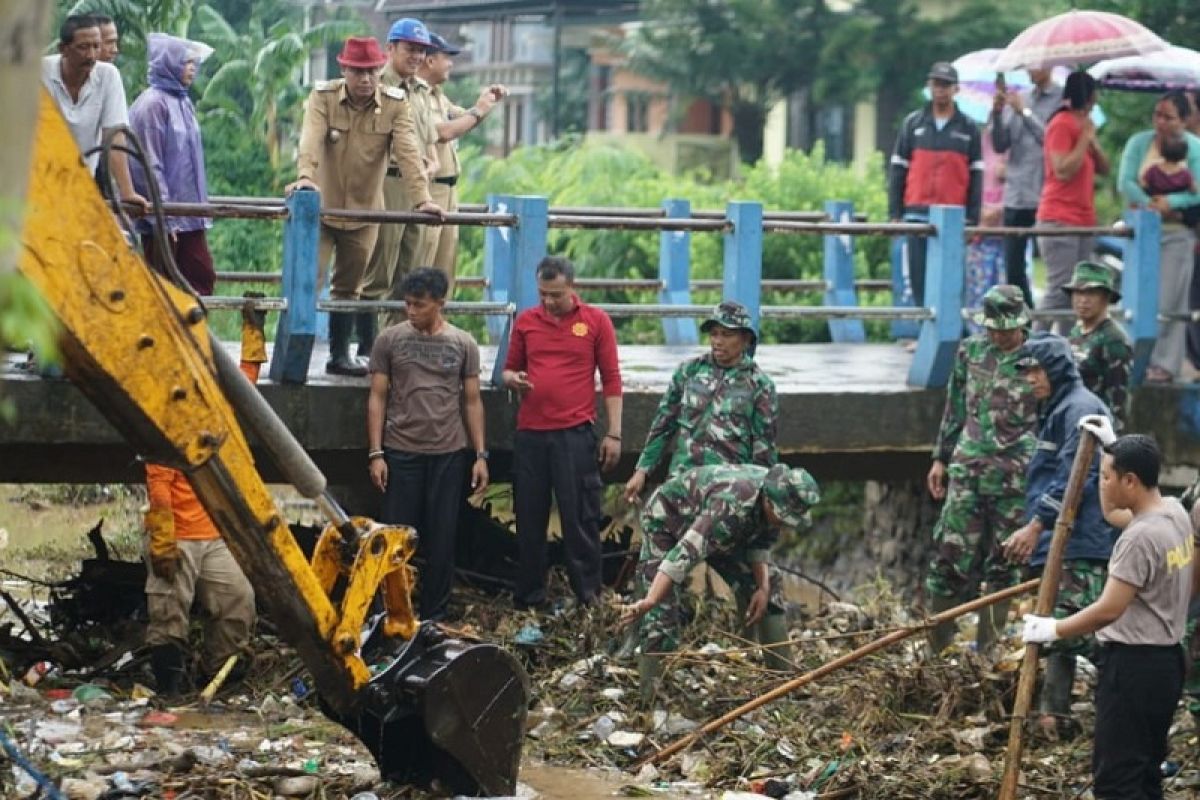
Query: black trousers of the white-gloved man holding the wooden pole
[{"left": 1092, "top": 644, "right": 1183, "bottom": 800}]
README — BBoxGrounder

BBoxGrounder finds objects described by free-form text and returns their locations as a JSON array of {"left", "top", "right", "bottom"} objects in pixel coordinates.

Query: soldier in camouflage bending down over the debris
[{"left": 622, "top": 464, "right": 821, "bottom": 699}]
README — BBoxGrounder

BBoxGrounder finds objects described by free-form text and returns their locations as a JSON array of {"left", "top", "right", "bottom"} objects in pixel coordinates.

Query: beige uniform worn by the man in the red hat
[{"left": 296, "top": 78, "right": 431, "bottom": 300}]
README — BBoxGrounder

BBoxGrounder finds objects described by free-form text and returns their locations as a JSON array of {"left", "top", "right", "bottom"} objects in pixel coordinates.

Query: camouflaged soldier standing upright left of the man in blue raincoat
[{"left": 925, "top": 285, "right": 1037, "bottom": 652}]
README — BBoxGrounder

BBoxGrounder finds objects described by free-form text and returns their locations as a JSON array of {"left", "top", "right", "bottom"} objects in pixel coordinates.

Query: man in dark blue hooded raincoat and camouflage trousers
[{"left": 1004, "top": 333, "right": 1117, "bottom": 734}]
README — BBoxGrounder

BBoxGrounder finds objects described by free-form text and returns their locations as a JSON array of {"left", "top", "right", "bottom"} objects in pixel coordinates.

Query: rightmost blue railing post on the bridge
[{"left": 1121, "top": 209, "right": 1163, "bottom": 386}]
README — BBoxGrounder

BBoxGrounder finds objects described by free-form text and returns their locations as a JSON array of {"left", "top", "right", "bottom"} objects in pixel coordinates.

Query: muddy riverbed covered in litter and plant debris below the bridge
[{"left": 7, "top": 487, "right": 1200, "bottom": 800}]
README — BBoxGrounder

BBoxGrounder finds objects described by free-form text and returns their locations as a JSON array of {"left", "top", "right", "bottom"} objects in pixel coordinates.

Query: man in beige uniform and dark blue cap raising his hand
[{"left": 416, "top": 32, "right": 509, "bottom": 300}]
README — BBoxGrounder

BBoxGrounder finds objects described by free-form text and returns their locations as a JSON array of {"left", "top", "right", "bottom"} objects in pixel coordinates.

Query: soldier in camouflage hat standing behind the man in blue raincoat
[{"left": 1062, "top": 261, "right": 1133, "bottom": 434}]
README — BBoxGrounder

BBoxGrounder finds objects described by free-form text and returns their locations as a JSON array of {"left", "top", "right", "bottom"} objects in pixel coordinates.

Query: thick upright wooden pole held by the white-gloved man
[{"left": 998, "top": 432, "right": 1096, "bottom": 800}]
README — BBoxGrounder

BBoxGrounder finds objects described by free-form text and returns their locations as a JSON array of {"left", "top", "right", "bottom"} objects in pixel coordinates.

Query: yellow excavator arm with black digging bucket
[{"left": 19, "top": 90, "right": 528, "bottom": 794}]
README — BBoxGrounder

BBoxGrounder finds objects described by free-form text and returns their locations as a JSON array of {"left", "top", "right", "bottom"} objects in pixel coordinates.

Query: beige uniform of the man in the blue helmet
[{"left": 362, "top": 64, "right": 438, "bottom": 309}]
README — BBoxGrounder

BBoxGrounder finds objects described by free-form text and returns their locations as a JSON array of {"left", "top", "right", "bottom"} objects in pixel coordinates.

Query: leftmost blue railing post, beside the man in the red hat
[{"left": 268, "top": 190, "right": 320, "bottom": 384}]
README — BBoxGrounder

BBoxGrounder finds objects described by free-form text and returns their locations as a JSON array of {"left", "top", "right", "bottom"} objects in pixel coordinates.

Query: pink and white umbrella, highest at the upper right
[{"left": 996, "top": 11, "right": 1168, "bottom": 70}]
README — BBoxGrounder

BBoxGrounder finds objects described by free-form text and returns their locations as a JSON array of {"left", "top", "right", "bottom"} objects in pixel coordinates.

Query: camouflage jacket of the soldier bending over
[{"left": 642, "top": 464, "right": 779, "bottom": 583}]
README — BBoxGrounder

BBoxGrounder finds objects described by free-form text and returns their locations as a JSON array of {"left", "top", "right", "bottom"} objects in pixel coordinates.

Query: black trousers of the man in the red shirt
[{"left": 512, "top": 423, "right": 604, "bottom": 606}]
